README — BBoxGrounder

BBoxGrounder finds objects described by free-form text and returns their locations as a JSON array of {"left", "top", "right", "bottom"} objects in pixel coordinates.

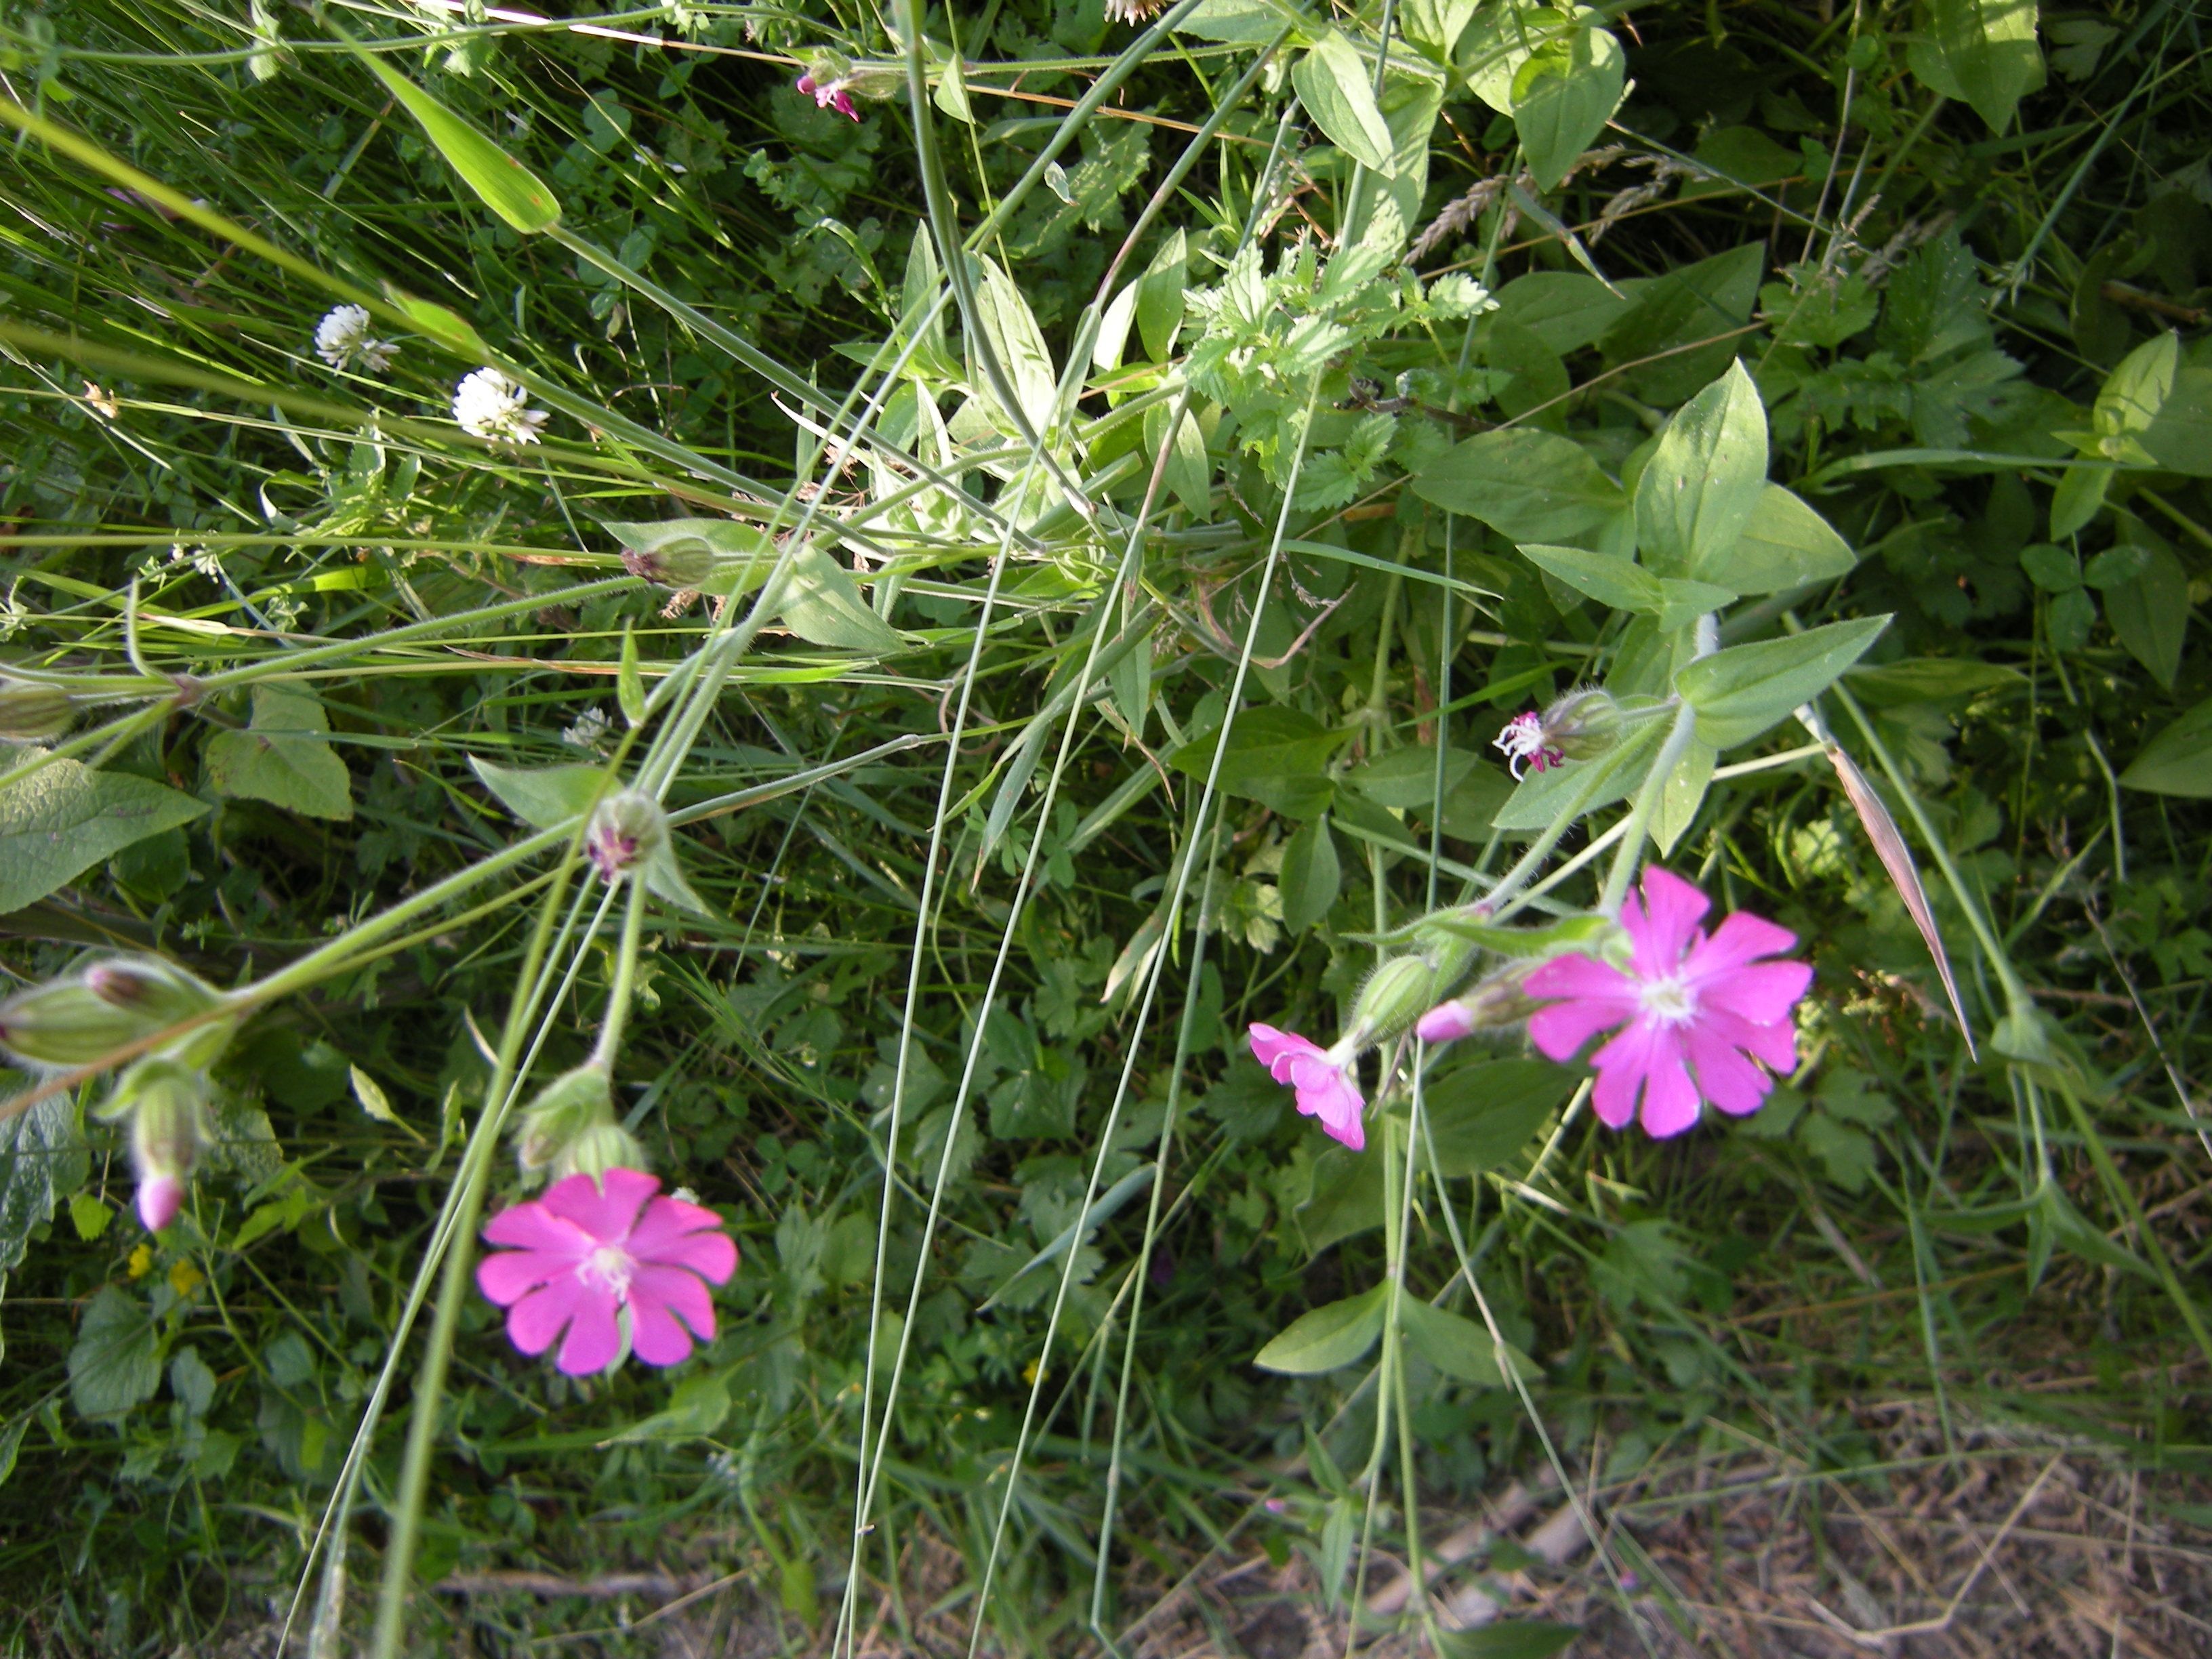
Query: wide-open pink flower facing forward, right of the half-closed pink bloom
[{"left": 1526, "top": 869, "right": 1811, "bottom": 1134}]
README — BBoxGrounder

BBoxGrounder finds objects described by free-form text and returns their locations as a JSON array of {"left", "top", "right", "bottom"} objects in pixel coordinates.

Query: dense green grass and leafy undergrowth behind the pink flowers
[{"left": 0, "top": 0, "right": 2212, "bottom": 1654}]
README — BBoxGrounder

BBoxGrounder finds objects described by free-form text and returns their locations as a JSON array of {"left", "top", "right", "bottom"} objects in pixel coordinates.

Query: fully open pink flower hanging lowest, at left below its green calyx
[{"left": 476, "top": 1168, "right": 737, "bottom": 1376}]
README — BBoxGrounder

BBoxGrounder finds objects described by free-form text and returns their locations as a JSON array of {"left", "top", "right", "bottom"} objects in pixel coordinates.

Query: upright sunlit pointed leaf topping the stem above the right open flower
[{"left": 1637, "top": 361, "right": 1767, "bottom": 586}]
